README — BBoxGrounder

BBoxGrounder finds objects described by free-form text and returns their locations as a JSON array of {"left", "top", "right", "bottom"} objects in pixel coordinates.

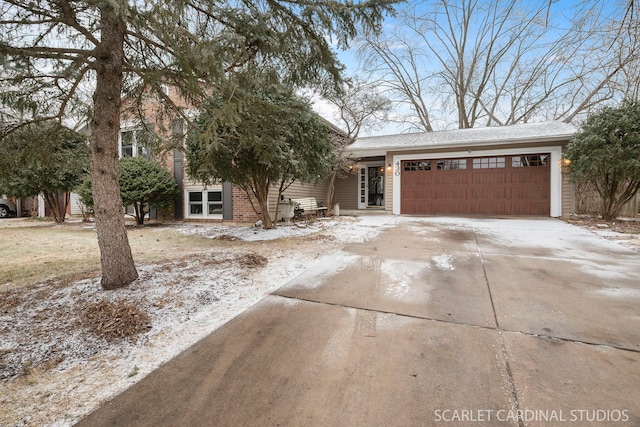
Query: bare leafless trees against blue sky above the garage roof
[{"left": 358, "top": 0, "right": 640, "bottom": 131}]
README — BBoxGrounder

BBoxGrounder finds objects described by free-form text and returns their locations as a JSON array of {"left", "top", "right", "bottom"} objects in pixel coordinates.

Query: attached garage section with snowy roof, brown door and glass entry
[{"left": 335, "top": 122, "right": 576, "bottom": 217}]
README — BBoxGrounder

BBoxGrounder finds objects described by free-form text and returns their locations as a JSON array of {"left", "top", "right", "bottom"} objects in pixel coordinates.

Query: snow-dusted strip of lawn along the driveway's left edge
[{"left": 0, "top": 217, "right": 384, "bottom": 426}]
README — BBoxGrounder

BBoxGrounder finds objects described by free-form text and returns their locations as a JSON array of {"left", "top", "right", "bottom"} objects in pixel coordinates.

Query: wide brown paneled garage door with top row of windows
[{"left": 400, "top": 153, "right": 551, "bottom": 215}]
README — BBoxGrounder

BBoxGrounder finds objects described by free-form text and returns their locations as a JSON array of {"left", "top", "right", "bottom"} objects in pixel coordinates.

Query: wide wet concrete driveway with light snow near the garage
[{"left": 79, "top": 217, "right": 640, "bottom": 426}]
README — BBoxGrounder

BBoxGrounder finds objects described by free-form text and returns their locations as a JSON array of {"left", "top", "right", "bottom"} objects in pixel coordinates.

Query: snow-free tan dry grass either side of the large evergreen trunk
[{"left": 0, "top": 221, "right": 226, "bottom": 291}]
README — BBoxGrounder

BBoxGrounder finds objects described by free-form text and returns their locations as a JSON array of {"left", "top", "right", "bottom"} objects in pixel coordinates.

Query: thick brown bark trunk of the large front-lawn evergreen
[{"left": 90, "top": 8, "right": 138, "bottom": 289}]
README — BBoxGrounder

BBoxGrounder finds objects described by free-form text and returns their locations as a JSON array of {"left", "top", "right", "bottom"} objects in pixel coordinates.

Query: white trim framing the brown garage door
[{"left": 392, "top": 146, "right": 562, "bottom": 218}]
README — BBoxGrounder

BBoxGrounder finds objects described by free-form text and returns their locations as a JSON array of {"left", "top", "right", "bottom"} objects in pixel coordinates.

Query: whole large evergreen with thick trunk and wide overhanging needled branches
[{"left": 0, "top": 0, "right": 394, "bottom": 289}]
